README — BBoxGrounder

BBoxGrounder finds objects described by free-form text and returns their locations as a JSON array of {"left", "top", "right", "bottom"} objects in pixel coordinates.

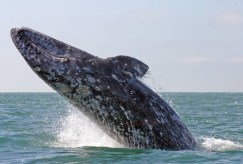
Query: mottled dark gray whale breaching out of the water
[{"left": 11, "top": 28, "right": 196, "bottom": 150}]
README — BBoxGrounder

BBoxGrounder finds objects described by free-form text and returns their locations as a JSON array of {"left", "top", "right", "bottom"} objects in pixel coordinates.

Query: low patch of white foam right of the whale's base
[{"left": 201, "top": 137, "right": 243, "bottom": 151}]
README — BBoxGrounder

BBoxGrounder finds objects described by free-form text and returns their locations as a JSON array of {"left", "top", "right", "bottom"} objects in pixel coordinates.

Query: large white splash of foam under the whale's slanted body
[{"left": 55, "top": 107, "right": 124, "bottom": 148}]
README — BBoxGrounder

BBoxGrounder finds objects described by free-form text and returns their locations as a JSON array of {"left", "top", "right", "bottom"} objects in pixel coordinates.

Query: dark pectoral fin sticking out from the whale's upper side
[{"left": 110, "top": 56, "right": 149, "bottom": 77}]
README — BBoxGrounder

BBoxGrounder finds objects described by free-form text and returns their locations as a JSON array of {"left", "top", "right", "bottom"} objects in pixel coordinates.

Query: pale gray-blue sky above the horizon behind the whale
[{"left": 0, "top": 0, "right": 243, "bottom": 92}]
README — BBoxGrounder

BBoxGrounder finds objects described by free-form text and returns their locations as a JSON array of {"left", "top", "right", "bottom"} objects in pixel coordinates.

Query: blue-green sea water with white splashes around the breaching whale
[{"left": 0, "top": 93, "right": 243, "bottom": 163}]
